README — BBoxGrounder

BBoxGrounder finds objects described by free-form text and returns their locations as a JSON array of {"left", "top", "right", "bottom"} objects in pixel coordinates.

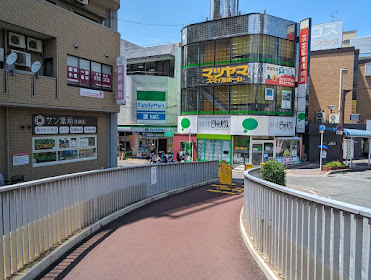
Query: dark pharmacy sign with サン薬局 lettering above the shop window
[{"left": 32, "top": 114, "right": 98, "bottom": 135}]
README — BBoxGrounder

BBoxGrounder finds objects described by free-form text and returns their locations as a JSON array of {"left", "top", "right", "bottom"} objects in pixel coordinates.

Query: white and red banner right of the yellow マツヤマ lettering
[{"left": 265, "top": 63, "right": 295, "bottom": 87}]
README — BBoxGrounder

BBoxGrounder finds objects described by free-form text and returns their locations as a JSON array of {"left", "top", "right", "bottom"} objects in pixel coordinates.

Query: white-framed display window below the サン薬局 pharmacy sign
[{"left": 32, "top": 135, "right": 97, "bottom": 166}]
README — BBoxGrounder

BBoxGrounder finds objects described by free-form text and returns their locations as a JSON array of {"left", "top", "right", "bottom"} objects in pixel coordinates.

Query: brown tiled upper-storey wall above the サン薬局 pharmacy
[{"left": 0, "top": 0, "right": 120, "bottom": 112}]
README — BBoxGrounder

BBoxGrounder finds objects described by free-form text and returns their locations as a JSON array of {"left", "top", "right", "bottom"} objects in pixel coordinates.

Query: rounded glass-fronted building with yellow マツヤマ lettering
[{"left": 174, "top": 12, "right": 302, "bottom": 165}]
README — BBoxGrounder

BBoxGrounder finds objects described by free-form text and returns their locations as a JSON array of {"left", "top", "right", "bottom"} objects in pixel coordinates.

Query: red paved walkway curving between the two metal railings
[{"left": 43, "top": 184, "right": 265, "bottom": 280}]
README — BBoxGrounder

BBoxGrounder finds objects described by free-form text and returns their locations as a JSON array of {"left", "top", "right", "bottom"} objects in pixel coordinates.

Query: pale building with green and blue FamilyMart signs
[{"left": 118, "top": 40, "right": 181, "bottom": 158}]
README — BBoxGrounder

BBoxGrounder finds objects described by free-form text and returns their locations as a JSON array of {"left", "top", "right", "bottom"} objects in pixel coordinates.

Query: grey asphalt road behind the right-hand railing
[{"left": 287, "top": 170, "right": 371, "bottom": 208}]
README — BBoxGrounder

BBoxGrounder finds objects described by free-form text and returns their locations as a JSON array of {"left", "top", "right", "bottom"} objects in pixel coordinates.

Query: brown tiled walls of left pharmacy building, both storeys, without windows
[{"left": 0, "top": 0, "right": 120, "bottom": 181}]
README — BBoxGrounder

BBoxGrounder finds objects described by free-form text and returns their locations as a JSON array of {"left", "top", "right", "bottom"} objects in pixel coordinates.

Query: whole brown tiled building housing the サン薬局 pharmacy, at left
[{"left": 0, "top": 0, "right": 120, "bottom": 181}]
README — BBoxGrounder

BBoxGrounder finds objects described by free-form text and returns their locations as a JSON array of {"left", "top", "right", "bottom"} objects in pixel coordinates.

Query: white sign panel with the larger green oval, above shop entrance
[{"left": 231, "top": 116, "right": 269, "bottom": 135}]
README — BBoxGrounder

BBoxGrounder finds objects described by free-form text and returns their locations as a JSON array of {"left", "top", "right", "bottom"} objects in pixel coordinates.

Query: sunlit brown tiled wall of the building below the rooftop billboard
[{"left": 308, "top": 48, "right": 355, "bottom": 123}]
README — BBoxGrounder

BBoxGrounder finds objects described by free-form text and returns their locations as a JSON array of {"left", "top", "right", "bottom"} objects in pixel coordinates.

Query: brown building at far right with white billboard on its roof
[{"left": 304, "top": 21, "right": 371, "bottom": 161}]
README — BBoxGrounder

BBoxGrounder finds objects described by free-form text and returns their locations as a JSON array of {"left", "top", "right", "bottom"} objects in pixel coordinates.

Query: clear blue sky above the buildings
[{"left": 118, "top": 0, "right": 371, "bottom": 46}]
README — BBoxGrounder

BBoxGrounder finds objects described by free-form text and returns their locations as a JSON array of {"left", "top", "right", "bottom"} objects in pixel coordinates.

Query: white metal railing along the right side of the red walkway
[{"left": 243, "top": 169, "right": 371, "bottom": 279}]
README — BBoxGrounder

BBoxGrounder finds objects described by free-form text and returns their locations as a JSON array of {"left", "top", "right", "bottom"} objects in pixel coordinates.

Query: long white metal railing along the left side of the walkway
[{"left": 0, "top": 161, "right": 218, "bottom": 279}]
